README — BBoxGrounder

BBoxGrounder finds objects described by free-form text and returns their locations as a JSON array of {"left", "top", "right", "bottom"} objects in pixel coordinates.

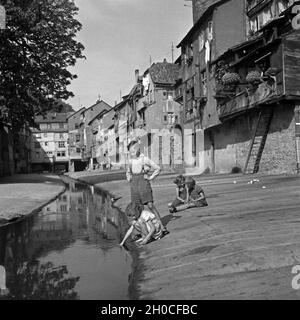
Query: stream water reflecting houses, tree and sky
[{"left": 0, "top": 181, "right": 132, "bottom": 300}]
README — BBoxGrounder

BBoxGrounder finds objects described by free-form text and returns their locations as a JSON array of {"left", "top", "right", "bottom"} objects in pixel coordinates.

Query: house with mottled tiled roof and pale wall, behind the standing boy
[{"left": 134, "top": 59, "right": 182, "bottom": 170}]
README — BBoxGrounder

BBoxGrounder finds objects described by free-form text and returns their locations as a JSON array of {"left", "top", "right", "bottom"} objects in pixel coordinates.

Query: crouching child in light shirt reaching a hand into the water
[{"left": 120, "top": 203, "right": 163, "bottom": 246}]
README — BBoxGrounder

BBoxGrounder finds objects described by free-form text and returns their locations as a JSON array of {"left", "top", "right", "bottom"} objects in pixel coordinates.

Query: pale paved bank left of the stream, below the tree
[{"left": 0, "top": 174, "right": 65, "bottom": 227}]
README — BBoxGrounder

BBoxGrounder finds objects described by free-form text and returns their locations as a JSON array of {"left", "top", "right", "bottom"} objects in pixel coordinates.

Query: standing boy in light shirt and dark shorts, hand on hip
[{"left": 126, "top": 140, "right": 168, "bottom": 234}]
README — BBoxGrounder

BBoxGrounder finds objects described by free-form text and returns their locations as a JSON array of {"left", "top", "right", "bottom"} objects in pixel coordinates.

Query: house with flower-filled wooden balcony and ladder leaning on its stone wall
[{"left": 205, "top": 0, "right": 300, "bottom": 173}]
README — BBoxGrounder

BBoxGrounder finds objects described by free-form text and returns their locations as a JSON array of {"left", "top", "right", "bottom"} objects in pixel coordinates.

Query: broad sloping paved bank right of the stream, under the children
[{"left": 68, "top": 171, "right": 300, "bottom": 299}]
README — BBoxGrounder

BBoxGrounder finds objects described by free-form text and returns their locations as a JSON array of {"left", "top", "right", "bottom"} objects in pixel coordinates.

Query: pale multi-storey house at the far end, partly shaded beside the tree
[{"left": 30, "top": 112, "right": 69, "bottom": 172}]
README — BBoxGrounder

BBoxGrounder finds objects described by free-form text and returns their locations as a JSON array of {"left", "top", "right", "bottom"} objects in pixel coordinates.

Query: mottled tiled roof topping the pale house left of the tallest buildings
[{"left": 149, "top": 61, "right": 179, "bottom": 85}]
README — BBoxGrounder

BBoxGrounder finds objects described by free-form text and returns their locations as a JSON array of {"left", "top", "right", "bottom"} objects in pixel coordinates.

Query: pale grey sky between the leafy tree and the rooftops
[{"left": 68, "top": 0, "right": 192, "bottom": 110}]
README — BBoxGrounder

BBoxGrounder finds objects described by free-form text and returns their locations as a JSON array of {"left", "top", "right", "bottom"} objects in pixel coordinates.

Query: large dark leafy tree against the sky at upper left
[{"left": 0, "top": 0, "right": 84, "bottom": 129}]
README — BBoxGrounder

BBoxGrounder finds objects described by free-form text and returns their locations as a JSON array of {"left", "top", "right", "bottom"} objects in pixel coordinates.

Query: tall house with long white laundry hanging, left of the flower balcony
[{"left": 176, "top": 0, "right": 246, "bottom": 172}]
